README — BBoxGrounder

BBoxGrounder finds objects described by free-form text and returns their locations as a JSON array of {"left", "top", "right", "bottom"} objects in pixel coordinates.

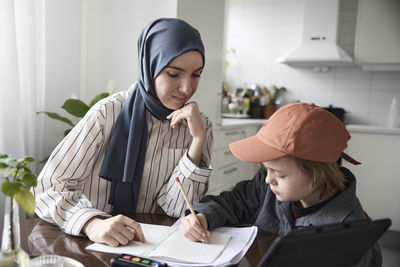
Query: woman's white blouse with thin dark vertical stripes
[{"left": 32, "top": 91, "right": 213, "bottom": 235}]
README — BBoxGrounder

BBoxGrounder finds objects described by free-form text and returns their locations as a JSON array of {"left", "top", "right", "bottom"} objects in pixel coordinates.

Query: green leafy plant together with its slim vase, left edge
[{"left": 0, "top": 153, "right": 37, "bottom": 266}]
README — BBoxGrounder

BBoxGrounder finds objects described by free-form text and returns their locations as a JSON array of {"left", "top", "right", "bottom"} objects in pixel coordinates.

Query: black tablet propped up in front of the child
[{"left": 258, "top": 219, "right": 391, "bottom": 267}]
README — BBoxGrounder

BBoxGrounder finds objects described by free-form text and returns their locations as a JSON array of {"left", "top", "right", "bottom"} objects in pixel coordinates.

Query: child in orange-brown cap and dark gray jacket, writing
[{"left": 181, "top": 103, "right": 382, "bottom": 266}]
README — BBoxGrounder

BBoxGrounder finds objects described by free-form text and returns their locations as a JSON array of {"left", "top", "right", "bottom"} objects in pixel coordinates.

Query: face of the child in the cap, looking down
[{"left": 262, "top": 157, "right": 320, "bottom": 207}]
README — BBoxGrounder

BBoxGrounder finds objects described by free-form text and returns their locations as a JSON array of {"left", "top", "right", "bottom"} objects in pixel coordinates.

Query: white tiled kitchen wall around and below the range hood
[{"left": 225, "top": 0, "right": 400, "bottom": 126}]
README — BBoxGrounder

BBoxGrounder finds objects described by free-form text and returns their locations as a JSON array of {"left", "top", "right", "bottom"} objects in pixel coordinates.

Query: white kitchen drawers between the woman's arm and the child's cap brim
[{"left": 207, "top": 123, "right": 262, "bottom": 195}]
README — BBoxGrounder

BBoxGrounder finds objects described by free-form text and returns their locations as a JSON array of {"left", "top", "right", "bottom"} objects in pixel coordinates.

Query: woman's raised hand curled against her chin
[{"left": 167, "top": 102, "right": 206, "bottom": 139}]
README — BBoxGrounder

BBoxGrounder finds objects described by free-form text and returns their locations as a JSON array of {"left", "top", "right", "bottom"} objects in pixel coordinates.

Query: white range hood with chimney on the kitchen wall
[{"left": 278, "top": 0, "right": 353, "bottom": 67}]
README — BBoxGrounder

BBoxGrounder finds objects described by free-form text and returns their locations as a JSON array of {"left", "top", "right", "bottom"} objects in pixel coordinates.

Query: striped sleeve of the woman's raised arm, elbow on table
[{"left": 158, "top": 120, "right": 213, "bottom": 217}]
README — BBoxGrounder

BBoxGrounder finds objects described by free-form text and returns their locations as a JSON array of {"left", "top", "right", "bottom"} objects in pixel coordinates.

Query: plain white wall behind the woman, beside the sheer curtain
[{"left": 40, "top": 0, "right": 177, "bottom": 159}]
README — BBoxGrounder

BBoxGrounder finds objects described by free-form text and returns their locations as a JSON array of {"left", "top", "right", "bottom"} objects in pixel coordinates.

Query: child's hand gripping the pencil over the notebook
[{"left": 180, "top": 213, "right": 211, "bottom": 243}]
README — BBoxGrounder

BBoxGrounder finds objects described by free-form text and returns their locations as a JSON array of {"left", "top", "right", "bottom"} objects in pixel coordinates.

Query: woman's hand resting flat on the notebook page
[{"left": 82, "top": 215, "right": 145, "bottom": 247}]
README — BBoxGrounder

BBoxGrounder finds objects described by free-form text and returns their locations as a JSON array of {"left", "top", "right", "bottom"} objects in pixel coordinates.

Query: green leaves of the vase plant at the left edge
[{"left": 0, "top": 153, "right": 37, "bottom": 215}]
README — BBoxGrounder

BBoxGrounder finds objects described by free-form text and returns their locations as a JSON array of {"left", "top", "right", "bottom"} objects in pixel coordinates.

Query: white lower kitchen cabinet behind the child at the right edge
[{"left": 343, "top": 126, "right": 400, "bottom": 231}]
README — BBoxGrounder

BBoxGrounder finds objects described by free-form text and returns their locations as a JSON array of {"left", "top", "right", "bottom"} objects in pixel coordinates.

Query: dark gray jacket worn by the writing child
[{"left": 193, "top": 167, "right": 382, "bottom": 267}]
